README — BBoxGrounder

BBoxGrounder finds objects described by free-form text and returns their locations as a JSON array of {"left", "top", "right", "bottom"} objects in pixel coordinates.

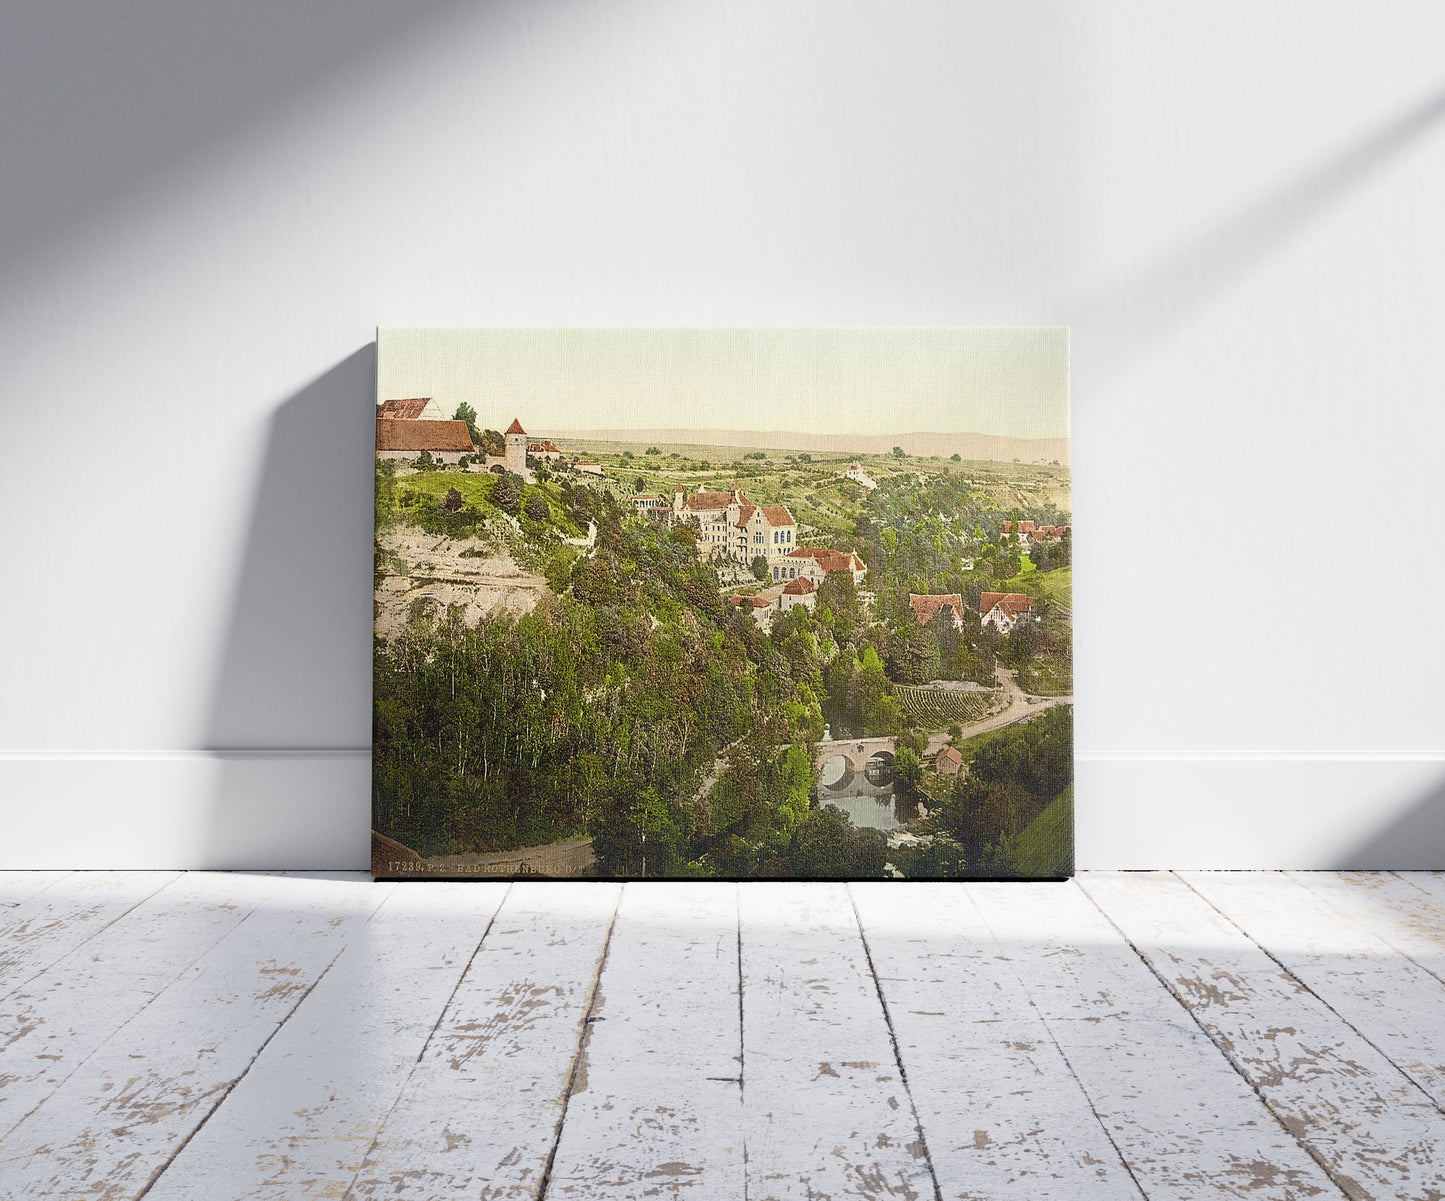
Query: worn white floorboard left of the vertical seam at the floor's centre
[{"left": 546, "top": 882, "right": 743, "bottom": 1201}]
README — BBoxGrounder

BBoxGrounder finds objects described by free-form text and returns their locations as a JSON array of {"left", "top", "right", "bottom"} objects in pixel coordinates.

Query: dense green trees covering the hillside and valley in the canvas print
[{"left": 373, "top": 465, "right": 1071, "bottom": 877}]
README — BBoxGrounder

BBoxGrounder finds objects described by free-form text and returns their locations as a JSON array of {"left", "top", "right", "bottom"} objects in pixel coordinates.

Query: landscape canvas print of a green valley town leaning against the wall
[{"left": 371, "top": 327, "right": 1074, "bottom": 880}]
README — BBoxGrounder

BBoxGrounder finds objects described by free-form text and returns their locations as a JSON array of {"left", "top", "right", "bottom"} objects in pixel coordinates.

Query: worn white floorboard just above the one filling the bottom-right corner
[{"left": 1181, "top": 871, "right": 1445, "bottom": 1107}]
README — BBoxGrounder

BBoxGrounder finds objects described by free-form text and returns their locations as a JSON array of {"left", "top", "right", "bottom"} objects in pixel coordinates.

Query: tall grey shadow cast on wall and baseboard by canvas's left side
[{"left": 202, "top": 344, "right": 376, "bottom": 869}]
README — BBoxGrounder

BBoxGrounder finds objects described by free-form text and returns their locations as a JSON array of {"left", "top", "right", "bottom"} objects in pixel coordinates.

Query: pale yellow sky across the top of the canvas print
[{"left": 377, "top": 325, "right": 1069, "bottom": 438}]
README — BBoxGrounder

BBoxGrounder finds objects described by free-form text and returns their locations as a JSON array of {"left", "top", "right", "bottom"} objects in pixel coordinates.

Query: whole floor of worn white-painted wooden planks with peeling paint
[{"left": 0, "top": 873, "right": 1445, "bottom": 1201}]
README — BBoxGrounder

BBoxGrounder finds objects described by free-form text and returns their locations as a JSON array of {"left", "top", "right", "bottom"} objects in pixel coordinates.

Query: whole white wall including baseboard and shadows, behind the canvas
[{"left": 0, "top": 0, "right": 1445, "bottom": 867}]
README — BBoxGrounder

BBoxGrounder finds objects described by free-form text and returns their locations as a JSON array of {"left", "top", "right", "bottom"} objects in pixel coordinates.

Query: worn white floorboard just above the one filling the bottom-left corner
[{"left": 0, "top": 871, "right": 294, "bottom": 1136}]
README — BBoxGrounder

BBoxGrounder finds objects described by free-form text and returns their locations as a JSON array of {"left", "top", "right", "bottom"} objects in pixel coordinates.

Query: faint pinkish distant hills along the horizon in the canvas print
[{"left": 532, "top": 429, "right": 1069, "bottom": 467}]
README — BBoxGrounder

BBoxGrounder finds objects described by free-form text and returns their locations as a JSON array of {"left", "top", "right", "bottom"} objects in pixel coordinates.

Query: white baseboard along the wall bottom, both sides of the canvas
[{"left": 0, "top": 749, "right": 1445, "bottom": 870}]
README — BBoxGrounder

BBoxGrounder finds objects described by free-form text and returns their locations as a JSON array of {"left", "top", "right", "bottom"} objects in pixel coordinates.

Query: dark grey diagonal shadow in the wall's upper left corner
[{"left": 0, "top": 0, "right": 464, "bottom": 278}]
